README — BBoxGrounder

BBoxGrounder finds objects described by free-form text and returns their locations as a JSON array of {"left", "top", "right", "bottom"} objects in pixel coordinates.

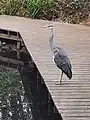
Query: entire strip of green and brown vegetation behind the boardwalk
[{"left": 0, "top": 0, "right": 90, "bottom": 23}]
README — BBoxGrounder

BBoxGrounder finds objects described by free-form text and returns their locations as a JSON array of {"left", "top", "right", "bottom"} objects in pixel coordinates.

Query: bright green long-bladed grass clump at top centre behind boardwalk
[{"left": 27, "top": 0, "right": 55, "bottom": 18}]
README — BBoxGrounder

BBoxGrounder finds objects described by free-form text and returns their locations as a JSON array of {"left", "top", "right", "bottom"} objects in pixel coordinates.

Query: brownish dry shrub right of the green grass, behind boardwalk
[{"left": 59, "top": 0, "right": 90, "bottom": 23}]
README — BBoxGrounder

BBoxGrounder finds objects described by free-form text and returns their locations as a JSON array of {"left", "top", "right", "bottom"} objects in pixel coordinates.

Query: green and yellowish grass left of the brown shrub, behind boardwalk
[{"left": 0, "top": 0, "right": 56, "bottom": 20}]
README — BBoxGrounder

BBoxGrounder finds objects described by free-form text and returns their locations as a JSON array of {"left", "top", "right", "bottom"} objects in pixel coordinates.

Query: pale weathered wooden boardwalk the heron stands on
[{"left": 0, "top": 16, "right": 90, "bottom": 120}]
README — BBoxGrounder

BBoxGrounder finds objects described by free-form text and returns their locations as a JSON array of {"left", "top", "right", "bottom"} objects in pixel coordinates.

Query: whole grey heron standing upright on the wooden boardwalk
[{"left": 42, "top": 24, "right": 72, "bottom": 84}]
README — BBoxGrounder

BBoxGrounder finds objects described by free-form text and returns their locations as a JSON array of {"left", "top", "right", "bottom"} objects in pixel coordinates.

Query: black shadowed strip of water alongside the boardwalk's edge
[{"left": 19, "top": 65, "right": 62, "bottom": 120}]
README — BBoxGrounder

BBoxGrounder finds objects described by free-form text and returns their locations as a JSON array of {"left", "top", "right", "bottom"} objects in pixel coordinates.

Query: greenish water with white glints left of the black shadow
[{"left": 0, "top": 66, "right": 33, "bottom": 120}]
